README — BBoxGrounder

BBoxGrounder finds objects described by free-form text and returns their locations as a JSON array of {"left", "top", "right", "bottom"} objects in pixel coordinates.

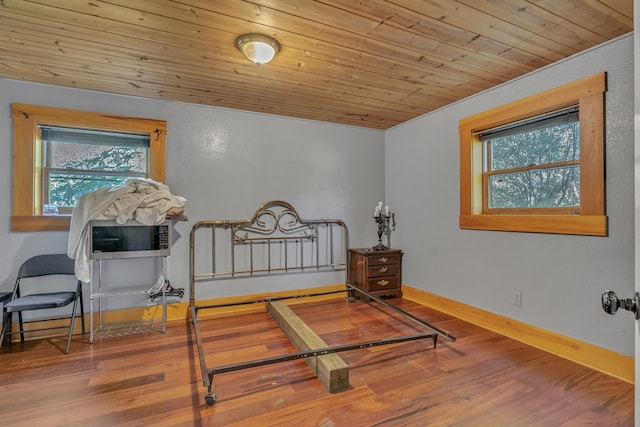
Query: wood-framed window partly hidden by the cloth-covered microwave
[{"left": 11, "top": 104, "right": 166, "bottom": 231}]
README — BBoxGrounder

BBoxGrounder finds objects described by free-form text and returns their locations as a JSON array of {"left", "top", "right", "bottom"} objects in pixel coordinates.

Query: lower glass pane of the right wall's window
[{"left": 489, "top": 165, "right": 580, "bottom": 209}]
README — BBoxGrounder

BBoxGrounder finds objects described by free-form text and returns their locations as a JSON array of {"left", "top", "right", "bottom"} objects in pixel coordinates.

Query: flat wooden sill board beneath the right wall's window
[{"left": 460, "top": 215, "right": 608, "bottom": 237}]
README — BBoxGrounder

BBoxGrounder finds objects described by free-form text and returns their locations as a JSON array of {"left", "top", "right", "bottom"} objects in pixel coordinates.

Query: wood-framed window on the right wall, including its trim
[{"left": 459, "top": 73, "right": 607, "bottom": 236}]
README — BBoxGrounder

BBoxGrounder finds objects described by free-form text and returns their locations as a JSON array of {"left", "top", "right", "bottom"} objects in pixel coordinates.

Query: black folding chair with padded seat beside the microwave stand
[{"left": 0, "top": 254, "right": 85, "bottom": 353}]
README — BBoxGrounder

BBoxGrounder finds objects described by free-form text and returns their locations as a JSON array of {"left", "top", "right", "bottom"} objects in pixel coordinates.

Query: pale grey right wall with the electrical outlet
[{"left": 385, "top": 35, "right": 634, "bottom": 355}]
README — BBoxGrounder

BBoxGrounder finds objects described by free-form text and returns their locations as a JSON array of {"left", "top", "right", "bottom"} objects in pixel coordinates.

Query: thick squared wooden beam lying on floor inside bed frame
[{"left": 266, "top": 301, "right": 349, "bottom": 393}]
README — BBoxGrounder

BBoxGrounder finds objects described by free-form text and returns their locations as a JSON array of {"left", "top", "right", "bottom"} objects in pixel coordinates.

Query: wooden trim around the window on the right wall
[{"left": 458, "top": 72, "right": 607, "bottom": 236}]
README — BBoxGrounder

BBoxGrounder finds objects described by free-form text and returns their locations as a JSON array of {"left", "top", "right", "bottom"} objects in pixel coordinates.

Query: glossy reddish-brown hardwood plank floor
[{"left": 0, "top": 299, "right": 634, "bottom": 427}]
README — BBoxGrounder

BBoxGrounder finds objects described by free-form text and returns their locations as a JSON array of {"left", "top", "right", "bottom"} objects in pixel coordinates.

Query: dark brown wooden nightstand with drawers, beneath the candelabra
[{"left": 349, "top": 248, "right": 402, "bottom": 302}]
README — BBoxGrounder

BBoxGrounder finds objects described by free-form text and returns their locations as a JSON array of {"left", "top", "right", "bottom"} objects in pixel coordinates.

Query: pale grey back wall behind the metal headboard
[{"left": 0, "top": 79, "right": 384, "bottom": 306}]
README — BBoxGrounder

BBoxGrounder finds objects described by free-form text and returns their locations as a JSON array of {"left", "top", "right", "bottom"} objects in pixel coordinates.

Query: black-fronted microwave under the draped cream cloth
[{"left": 89, "top": 220, "right": 171, "bottom": 259}]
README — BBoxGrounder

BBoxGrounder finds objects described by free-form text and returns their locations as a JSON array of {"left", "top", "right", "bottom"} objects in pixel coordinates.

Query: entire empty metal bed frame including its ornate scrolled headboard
[{"left": 189, "top": 200, "right": 455, "bottom": 405}]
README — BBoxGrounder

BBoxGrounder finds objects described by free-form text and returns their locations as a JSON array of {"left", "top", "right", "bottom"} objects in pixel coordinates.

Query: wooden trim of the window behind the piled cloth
[{"left": 11, "top": 104, "right": 167, "bottom": 231}]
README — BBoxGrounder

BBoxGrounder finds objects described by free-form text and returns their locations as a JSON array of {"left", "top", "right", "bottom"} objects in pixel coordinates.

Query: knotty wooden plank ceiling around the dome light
[{"left": 0, "top": 0, "right": 633, "bottom": 129}]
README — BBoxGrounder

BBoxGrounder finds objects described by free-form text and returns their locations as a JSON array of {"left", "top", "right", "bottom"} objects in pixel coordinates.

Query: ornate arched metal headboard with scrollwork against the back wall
[{"left": 190, "top": 200, "right": 349, "bottom": 298}]
